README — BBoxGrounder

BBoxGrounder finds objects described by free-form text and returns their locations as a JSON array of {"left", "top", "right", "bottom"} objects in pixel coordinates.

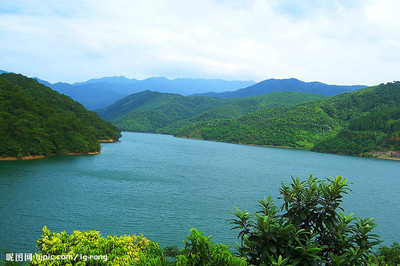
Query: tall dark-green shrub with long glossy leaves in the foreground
[{"left": 230, "top": 176, "right": 381, "bottom": 265}]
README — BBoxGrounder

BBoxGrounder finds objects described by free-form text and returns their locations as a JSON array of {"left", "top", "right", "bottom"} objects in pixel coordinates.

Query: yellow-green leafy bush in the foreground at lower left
[{"left": 32, "top": 226, "right": 168, "bottom": 265}]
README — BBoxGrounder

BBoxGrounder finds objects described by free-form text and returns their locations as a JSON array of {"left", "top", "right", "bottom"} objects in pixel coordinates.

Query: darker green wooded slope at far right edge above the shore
[{"left": 314, "top": 82, "right": 400, "bottom": 157}]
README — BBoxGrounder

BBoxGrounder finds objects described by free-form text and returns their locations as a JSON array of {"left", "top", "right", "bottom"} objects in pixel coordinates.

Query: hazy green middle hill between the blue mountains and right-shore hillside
[{"left": 98, "top": 91, "right": 324, "bottom": 134}]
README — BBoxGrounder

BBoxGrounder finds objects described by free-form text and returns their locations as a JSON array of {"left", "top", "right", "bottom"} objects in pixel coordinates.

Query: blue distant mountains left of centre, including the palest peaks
[{"left": 36, "top": 76, "right": 255, "bottom": 110}]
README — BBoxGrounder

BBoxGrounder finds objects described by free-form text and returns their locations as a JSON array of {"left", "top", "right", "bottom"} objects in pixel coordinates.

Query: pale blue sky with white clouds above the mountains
[{"left": 0, "top": 0, "right": 400, "bottom": 85}]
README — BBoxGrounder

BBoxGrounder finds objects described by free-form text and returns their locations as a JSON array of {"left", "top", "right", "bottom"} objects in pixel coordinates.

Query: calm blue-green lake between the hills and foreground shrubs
[{"left": 0, "top": 132, "right": 400, "bottom": 254}]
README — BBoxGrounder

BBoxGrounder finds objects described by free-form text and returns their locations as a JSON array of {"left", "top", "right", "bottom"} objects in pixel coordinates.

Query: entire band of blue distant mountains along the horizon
[{"left": 0, "top": 70, "right": 366, "bottom": 110}]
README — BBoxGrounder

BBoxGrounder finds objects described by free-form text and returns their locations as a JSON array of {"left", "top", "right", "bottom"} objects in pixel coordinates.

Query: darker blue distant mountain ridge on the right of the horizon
[{"left": 195, "top": 78, "right": 367, "bottom": 98}]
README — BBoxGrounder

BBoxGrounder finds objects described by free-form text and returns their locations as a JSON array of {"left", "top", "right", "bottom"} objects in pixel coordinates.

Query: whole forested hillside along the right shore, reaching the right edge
[{"left": 175, "top": 82, "right": 400, "bottom": 156}]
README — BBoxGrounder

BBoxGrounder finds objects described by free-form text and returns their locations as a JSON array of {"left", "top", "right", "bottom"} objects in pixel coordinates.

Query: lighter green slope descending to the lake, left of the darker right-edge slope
[{"left": 175, "top": 103, "right": 336, "bottom": 147}]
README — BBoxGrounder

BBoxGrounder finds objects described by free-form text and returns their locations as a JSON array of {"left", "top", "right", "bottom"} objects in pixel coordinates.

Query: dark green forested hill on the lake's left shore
[{"left": 0, "top": 73, "right": 121, "bottom": 158}]
